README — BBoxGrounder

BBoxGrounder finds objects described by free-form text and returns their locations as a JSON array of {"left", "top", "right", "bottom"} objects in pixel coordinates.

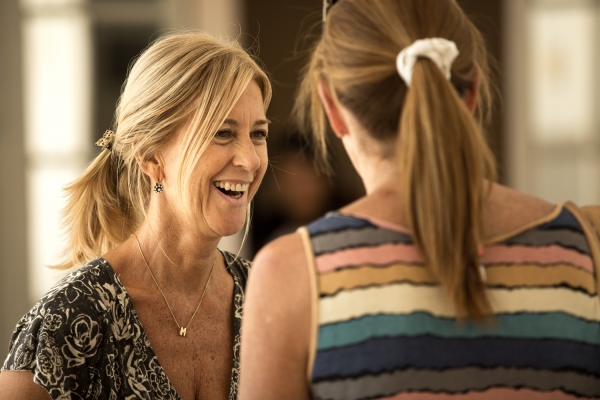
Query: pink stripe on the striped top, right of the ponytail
[{"left": 483, "top": 245, "right": 594, "bottom": 273}]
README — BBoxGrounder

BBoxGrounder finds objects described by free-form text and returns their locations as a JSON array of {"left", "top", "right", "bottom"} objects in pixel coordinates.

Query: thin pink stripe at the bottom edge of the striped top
[{"left": 380, "top": 388, "right": 579, "bottom": 400}]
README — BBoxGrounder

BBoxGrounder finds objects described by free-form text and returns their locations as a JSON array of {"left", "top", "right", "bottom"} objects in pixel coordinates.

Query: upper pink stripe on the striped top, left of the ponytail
[{"left": 316, "top": 244, "right": 423, "bottom": 273}]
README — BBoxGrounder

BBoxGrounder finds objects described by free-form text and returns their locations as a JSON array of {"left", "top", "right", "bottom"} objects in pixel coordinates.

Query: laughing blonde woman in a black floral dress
[{"left": 0, "top": 32, "right": 271, "bottom": 399}]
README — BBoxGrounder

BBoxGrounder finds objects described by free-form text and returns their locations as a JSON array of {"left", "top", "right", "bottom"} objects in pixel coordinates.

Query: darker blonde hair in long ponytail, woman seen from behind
[{"left": 295, "top": 0, "right": 496, "bottom": 318}]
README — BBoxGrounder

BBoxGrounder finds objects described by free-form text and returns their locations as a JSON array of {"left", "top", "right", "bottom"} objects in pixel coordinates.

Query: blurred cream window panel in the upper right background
[{"left": 503, "top": 0, "right": 600, "bottom": 205}]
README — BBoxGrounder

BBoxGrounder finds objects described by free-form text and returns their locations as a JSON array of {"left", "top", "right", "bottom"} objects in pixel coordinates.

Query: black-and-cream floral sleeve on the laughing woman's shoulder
[{"left": 2, "top": 258, "right": 160, "bottom": 398}]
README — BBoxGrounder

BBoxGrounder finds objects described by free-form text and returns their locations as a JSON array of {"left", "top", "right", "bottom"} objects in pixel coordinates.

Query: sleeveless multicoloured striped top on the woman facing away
[{"left": 301, "top": 205, "right": 600, "bottom": 400}]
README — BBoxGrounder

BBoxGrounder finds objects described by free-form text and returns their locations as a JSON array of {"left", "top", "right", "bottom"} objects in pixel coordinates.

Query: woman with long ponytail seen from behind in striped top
[{"left": 240, "top": 0, "right": 600, "bottom": 400}]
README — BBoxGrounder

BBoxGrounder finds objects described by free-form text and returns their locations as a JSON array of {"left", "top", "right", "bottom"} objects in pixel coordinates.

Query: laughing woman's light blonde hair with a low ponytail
[{"left": 56, "top": 32, "right": 271, "bottom": 268}]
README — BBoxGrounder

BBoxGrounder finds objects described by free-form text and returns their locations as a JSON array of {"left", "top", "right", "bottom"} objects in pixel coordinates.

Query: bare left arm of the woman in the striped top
[{"left": 239, "top": 234, "right": 311, "bottom": 400}]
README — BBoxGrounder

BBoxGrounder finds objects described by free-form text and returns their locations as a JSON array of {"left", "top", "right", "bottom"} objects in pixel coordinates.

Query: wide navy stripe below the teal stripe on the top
[{"left": 313, "top": 336, "right": 600, "bottom": 381}]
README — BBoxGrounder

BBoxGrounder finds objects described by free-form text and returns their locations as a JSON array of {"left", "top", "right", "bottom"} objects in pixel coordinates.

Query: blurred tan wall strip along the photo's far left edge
[{"left": 0, "top": 0, "right": 31, "bottom": 363}]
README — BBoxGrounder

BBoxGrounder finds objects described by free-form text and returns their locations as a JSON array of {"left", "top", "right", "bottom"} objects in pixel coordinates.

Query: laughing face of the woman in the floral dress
[{"left": 161, "top": 81, "right": 268, "bottom": 237}]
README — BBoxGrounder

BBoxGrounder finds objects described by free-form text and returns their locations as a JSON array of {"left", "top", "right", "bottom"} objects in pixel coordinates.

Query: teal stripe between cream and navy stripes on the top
[{"left": 317, "top": 312, "right": 600, "bottom": 350}]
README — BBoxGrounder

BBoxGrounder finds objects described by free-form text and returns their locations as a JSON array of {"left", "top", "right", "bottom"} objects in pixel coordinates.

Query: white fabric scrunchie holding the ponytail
[{"left": 396, "top": 38, "right": 459, "bottom": 86}]
